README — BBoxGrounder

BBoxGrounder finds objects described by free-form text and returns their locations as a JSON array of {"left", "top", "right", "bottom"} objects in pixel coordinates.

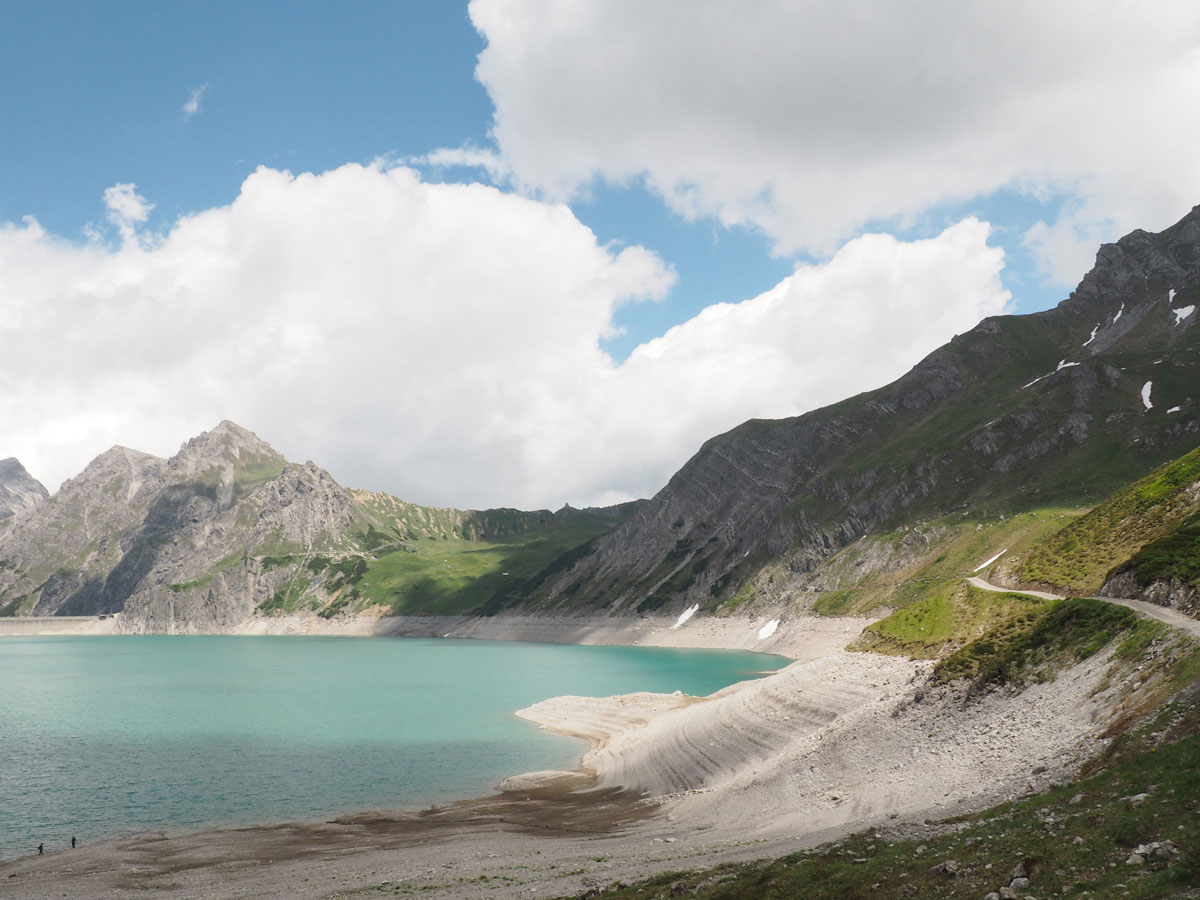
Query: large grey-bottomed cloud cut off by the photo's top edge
[{"left": 469, "top": 0, "right": 1200, "bottom": 283}]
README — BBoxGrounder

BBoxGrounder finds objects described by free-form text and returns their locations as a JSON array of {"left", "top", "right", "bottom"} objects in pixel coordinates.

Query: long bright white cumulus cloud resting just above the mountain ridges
[{"left": 0, "top": 164, "right": 1007, "bottom": 508}]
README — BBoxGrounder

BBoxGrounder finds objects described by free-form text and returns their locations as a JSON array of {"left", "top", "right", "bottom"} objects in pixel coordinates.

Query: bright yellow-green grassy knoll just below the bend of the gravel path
[{"left": 851, "top": 581, "right": 1052, "bottom": 659}]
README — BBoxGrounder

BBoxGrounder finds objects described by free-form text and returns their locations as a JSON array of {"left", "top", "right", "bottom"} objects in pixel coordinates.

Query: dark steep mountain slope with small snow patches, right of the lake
[{"left": 513, "top": 208, "right": 1200, "bottom": 613}]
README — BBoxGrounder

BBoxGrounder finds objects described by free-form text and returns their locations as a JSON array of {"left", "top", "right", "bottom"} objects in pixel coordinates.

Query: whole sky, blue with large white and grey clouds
[{"left": 0, "top": 0, "right": 1200, "bottom": 509}]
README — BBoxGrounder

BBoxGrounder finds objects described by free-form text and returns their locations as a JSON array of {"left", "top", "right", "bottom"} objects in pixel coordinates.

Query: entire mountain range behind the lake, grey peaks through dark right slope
[{"left": 0, "top": 208, "right": 1200, "bottom": 631}]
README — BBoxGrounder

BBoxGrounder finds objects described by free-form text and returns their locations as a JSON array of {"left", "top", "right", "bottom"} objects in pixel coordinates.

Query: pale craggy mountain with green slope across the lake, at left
[{"left": 0, "top": 421, "right": 634, "bottom": 632}]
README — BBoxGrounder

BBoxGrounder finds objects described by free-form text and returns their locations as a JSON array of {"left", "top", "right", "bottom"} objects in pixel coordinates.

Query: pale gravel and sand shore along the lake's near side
[{"left": 0, "top": 618, "right": 1120, "bottom": 899}]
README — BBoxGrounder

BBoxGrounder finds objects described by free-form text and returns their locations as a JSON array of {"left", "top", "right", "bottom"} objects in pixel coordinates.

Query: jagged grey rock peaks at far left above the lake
[{"left": 0, "top": 422, "right": 309, "bottom": 620}]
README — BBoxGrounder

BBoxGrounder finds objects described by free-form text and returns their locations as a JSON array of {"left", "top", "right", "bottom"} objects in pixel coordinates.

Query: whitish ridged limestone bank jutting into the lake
[{"left": 518, "top": 650, "right": 1121, "bottom": 841}]
